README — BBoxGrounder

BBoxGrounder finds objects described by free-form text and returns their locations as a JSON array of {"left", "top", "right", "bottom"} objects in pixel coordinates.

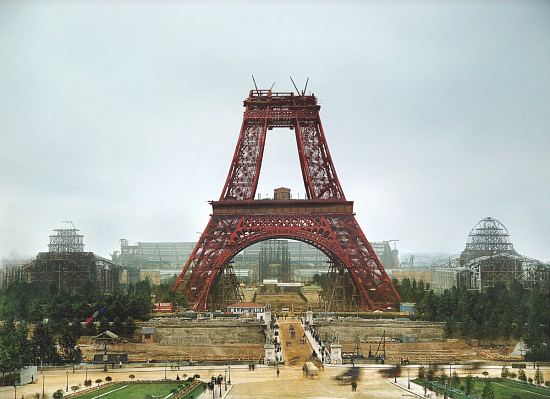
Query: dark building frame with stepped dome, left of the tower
[{"left": 3, "top": 222, "right": 119, "bottom": 293}]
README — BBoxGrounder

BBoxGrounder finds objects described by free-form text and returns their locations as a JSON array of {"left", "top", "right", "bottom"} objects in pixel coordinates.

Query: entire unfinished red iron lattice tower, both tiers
[{"left": 173, "top": 90, "right": 399, "bottom": 311}]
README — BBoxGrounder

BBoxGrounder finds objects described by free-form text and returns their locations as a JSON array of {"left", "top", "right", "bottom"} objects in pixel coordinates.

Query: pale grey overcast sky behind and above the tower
[{"left": 0, "top": 1, "right": 550, "bottom": 260}]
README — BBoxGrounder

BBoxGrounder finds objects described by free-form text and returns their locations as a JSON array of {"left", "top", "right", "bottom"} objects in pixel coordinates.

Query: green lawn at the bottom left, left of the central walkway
[{"left": 74, "top": 382, "right": 202, "bottom": 399}]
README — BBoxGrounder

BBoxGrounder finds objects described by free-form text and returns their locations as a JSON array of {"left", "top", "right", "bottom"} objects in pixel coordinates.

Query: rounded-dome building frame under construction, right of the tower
[{"left": 432, "top": 217, "right": 550, "bottom": 291}]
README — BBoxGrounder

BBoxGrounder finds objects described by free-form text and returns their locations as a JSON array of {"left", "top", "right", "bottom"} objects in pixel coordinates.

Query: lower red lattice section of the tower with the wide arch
[{"left": 176, "top": 200, "right": 399, "bottom": 310}]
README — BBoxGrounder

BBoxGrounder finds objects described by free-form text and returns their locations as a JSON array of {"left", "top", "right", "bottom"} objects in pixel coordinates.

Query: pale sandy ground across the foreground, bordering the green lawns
[{"left": 0, "top": 364, "right": 550, "bottom": 399}]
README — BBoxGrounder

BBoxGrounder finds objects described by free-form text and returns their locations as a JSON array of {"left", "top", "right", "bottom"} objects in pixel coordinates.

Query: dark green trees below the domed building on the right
[{"left": 394, "top": 278, "right": 550, "bottom": 360}]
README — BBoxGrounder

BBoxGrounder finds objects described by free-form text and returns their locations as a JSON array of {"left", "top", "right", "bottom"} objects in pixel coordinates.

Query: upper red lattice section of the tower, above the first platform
[{"left": 220, "top": 91, "right": 345, "bottom": 201}]
